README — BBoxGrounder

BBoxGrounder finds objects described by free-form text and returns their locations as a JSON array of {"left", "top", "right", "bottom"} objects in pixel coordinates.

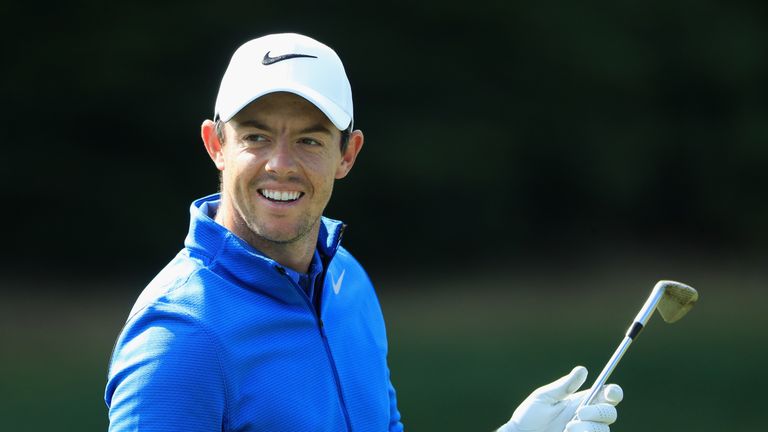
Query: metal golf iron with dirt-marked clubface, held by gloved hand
[{"left": 577, "top": 280, "right": 699, "bottom": 410}]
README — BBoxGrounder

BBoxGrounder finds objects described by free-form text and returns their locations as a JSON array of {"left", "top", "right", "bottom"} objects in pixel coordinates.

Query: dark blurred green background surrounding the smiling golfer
[{"left": 0, "top": 0, "right": 768, "bottom": 430}]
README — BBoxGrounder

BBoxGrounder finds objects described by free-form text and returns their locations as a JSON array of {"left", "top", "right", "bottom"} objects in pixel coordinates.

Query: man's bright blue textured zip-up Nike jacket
[{"left": 105, "top": 195, "right": 403, "bottom": 432}]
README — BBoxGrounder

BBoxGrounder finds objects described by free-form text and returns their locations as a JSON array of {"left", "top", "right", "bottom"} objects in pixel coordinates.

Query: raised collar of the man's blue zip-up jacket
[{"left": 184, "top": 194, "right": 346, "bottom": 292}]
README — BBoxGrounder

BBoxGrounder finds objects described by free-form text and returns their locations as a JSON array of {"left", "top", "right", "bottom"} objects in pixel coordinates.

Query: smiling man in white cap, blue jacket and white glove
[{"left": 105, "top": 34, "right": 620, "bottom": 432}]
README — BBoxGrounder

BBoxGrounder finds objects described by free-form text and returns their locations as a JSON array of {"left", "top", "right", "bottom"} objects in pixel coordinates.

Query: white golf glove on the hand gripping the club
[{"left": 497, "top": 366, "right": 624, "bottom": 432}]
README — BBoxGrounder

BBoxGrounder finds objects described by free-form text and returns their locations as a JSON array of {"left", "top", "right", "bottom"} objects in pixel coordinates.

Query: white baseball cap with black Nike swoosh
[{"left": 214, "top": 33, "right": 353, "bottom": 130}]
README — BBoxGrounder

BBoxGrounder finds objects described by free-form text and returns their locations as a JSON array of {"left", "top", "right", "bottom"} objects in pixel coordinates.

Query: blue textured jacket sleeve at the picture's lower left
[{"left": 105, "top": 311, "right": 226, "bottom": 432}]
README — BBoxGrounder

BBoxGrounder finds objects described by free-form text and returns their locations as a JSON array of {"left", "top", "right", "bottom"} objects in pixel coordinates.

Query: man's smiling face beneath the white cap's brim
[{"left": 209, "top": 93, "right": 362, "bottom": 248}]
